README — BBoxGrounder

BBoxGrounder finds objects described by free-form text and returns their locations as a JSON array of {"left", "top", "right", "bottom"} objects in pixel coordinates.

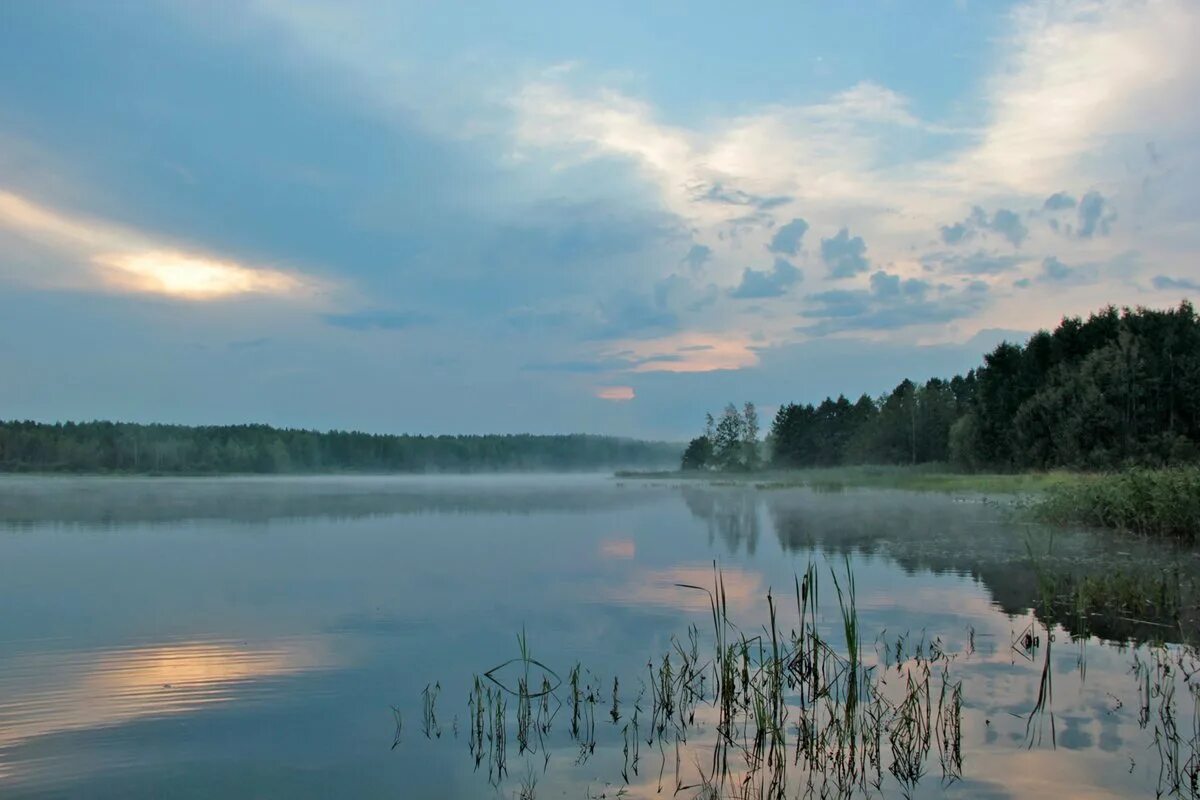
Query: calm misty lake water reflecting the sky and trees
[{"left": 0, "top": 476, "right": 1198, "bottom": 798}]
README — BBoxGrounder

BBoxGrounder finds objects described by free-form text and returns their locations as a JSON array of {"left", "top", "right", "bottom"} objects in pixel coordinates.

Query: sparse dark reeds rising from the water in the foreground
[{"left": 394, "top": 561, "right": 1200, "bottom": 800}]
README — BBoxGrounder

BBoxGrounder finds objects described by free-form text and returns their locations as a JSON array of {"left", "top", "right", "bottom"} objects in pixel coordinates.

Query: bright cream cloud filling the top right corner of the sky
[{"left": 948, "top": 0, "right": 1196, "bottom": 192}]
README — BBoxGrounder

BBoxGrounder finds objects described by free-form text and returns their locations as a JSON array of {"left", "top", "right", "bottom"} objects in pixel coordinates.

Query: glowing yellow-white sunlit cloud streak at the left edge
[{"left": 0, "top": 191, "right": 326, "bottom": 301}]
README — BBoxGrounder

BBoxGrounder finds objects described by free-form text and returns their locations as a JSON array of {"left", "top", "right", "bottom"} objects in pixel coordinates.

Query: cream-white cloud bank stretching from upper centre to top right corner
[{"left": 512, "top": 0, "right": 1200, "bottom": 343}]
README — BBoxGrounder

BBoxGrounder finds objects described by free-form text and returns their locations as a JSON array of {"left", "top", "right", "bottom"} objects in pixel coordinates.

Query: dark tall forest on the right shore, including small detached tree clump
[{"left": 682, "top": 301, "right": 1200, "bottom": 471}]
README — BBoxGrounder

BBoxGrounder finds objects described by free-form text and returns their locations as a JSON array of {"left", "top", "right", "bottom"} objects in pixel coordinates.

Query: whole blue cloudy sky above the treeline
[{"left": 0, "top": 0, "right": 1200, "bottom": 439}]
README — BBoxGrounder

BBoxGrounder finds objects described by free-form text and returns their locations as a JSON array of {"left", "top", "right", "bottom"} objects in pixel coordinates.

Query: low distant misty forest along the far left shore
[{"left": 0, "top": 421, "right": 679, "bottom": 474}]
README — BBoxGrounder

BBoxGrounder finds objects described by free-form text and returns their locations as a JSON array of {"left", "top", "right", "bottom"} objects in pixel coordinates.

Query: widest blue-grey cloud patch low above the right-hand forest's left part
[{"left": 797, "top": 270, "right": 988, "bottom": 336}]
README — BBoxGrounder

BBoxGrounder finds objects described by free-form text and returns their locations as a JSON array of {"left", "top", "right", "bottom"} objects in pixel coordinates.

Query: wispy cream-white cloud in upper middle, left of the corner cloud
[{"left": 512, "top": 74, "right": 945, "bottom": 225}]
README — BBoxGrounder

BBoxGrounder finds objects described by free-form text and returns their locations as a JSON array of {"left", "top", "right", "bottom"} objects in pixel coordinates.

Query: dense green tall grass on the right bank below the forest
[{"left": 1033, "top": 467, "right": 1200, "bottom": 541}]
